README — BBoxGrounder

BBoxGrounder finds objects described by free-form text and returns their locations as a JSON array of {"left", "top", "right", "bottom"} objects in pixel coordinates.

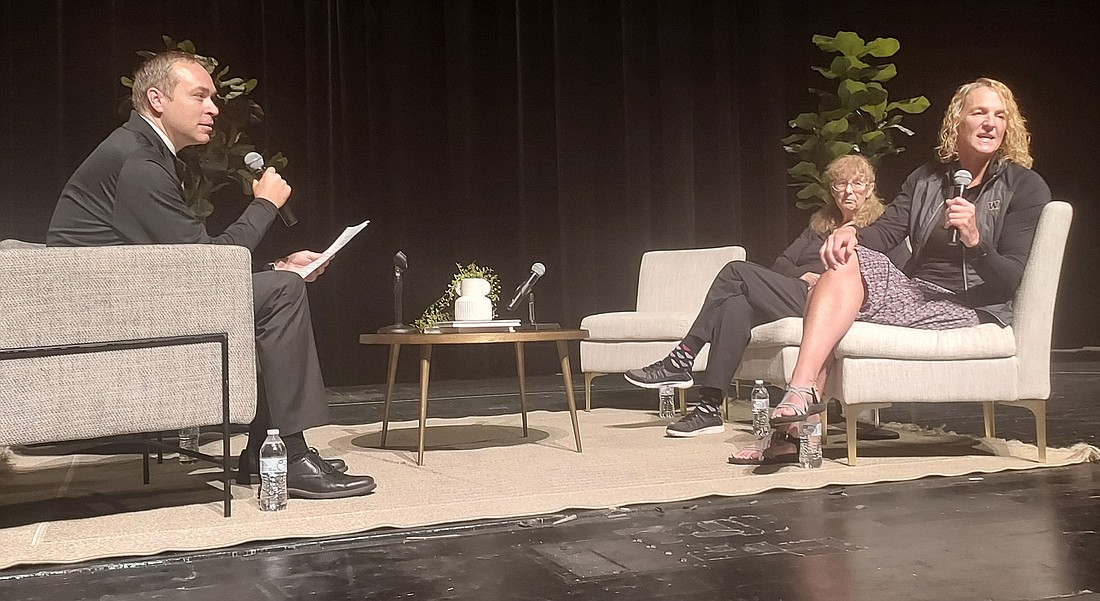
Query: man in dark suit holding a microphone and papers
[{"left": 46, "top": 52, "right": 375, "bottom": 499}]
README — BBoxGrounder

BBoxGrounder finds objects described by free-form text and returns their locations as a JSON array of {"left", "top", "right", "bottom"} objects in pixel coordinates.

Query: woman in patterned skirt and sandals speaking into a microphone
[{"left": 734, "top": 77, "right": 1051, "bottom": 456}]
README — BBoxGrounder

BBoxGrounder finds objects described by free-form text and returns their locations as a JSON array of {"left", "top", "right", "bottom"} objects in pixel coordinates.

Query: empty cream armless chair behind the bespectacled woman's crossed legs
[{"left": 581, "top": 247, "right": 745, "bottom": 411}]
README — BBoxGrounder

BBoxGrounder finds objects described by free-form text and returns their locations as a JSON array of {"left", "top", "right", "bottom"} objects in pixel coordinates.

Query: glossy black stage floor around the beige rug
[{"left": 0, "top": 360, "right": 1100, "bottom": 601}]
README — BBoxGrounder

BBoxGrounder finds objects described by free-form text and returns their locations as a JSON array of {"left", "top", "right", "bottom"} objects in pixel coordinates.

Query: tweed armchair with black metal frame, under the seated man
[{"left": 0, "top": 240, "right": 256, "bottom": 516}]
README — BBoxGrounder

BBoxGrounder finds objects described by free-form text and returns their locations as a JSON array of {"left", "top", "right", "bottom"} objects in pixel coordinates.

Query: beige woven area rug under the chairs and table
[{"left": 0, "top": 409, "right": 1100, "bottom": 568}]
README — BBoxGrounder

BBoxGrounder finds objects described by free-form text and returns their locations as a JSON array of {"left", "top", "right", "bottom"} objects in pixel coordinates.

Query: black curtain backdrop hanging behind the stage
[{"left": 0, "top": 0, "right": 1100, "bottom": 385}]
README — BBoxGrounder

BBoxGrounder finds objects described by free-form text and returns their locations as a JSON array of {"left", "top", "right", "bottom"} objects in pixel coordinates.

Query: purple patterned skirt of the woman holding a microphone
[{"left": 856, "top": 247, "right": 979, "bottom": 330}]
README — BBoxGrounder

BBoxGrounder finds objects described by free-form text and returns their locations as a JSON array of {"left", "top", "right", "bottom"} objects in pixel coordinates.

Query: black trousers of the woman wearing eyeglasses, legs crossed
[{"left": 688, "top": 261, "right": 809, "bottom": 404}]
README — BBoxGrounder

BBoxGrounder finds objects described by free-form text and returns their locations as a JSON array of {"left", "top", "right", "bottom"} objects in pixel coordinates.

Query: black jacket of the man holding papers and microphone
[{"left": 46, "top": 112, "right": 276, "bottom": 250}]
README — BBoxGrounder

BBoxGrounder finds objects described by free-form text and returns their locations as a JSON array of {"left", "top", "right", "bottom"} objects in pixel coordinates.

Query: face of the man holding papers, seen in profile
[{"left": 152, "top": 61, "right": 218, "bottom": 150}]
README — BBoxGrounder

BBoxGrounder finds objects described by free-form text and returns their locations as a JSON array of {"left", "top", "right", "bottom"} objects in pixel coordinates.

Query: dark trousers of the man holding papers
[{"left": 249, "top": 271, "right": 329, "bottom": 442}]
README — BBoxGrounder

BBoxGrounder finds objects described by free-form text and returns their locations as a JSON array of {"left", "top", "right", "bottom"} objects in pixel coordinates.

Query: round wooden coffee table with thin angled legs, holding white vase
[{"left": 359, "top": 329, "right": 589, "bottom": 466}]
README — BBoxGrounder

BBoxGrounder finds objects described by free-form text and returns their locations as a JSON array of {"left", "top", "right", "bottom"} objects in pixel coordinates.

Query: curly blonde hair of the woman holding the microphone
[{"left": 936, "top": 77, "right": 1032, "bottom": 168}]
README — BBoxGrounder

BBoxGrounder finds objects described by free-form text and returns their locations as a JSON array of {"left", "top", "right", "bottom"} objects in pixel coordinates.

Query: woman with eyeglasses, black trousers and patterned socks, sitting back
[{"left": 625, "top": 154, "right": 884, "bottom": 444}]
